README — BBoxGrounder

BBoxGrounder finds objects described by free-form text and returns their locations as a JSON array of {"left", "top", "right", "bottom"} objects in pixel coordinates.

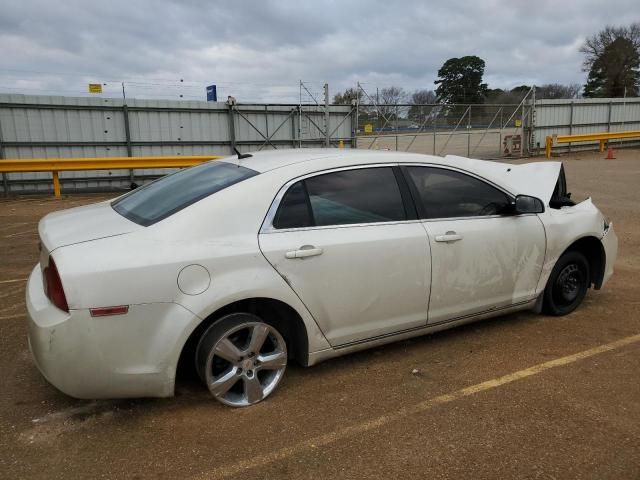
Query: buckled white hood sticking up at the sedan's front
[{"left": 445, "top": 155, "right": 562, "bottom": 205}]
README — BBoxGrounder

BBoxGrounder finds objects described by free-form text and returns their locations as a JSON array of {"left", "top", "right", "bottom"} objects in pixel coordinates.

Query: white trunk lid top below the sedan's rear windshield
[{"left": 38, "top": 201, "right": 143, "bottom": 252}]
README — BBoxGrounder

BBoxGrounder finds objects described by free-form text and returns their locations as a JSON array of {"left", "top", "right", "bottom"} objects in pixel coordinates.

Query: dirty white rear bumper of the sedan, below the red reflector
[{"left": 26, "top": 267, "right": 199, "bottom": 399}]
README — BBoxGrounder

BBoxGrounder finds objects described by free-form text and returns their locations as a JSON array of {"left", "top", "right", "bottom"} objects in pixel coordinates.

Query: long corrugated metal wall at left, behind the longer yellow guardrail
[{"left": 0, "top": 94, "right": 353, "bottom": 192}]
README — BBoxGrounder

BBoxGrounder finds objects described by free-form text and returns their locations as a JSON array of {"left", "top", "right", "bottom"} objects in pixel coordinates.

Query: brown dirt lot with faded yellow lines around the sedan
[{"left": 0, "top": 150, "right": 640, "bottom": 479}]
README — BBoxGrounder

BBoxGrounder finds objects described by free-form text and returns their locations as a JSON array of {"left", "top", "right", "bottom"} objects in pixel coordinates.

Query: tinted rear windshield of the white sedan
[{"left": 111, "top": 161, "right": 258, "bottom": 227}]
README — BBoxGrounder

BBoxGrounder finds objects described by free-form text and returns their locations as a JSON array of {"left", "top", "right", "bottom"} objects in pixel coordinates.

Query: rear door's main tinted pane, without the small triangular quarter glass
[{"left": 305, "top": 168, "right": 406, "bottom": 225}]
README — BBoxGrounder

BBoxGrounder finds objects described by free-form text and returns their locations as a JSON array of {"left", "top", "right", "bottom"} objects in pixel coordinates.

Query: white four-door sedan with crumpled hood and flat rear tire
[{"left": 27, "top": 149, "right": 618, "bottom": 406}]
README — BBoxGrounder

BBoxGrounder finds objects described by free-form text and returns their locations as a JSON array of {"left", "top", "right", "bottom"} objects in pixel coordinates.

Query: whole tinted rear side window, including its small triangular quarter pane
[{"left": 274, "top": 167, "right": 407, "bottom": 228}]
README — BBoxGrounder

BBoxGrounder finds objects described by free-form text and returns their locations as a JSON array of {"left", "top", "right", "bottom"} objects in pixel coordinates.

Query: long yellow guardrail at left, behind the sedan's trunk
[{"left": 0, "top": 155, "right": 222, "bottom": 198}]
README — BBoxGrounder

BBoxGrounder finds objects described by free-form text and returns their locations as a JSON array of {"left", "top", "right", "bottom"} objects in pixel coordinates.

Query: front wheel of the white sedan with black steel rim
[{"left": 542, "top": 251, "right": 591, "bottom": 316}]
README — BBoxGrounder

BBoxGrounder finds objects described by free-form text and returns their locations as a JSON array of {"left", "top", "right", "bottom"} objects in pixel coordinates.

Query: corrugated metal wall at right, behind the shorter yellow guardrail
[{"left": 532, "top": 98, "right": 640, "bottom": 150}]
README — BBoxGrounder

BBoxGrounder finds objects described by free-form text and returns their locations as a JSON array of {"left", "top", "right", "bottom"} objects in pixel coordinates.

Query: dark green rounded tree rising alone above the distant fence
[{"left": 434, "top": 56, "right": 487, "bottom": 103}]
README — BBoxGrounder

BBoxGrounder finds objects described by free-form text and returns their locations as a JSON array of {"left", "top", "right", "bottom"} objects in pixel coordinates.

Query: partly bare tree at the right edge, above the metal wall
[{"left": 580, "top": 23, "right": 640, "bottom": 97}]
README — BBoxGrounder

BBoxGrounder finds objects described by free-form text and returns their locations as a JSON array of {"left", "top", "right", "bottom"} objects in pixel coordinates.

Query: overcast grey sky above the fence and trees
[{"left": 0, "top": 0, "right": 640, "bottom": 102}]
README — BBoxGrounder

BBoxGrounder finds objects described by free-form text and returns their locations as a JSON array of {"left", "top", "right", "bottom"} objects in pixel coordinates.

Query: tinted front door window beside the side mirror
[{"left": 407, "top": 167, "right": 510, "bottom": 218}]
